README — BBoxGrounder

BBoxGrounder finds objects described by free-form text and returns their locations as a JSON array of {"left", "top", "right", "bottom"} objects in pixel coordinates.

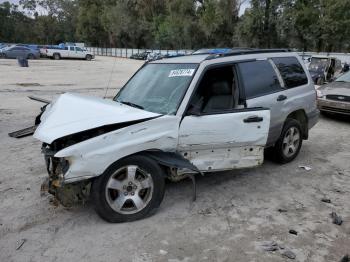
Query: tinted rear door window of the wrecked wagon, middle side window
[{"left": 238, "top": 60, "right": 282, "bottom": 99}]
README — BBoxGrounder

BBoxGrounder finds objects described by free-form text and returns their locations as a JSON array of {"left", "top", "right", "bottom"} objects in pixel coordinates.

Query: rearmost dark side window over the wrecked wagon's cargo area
[{"left": 272, "top": 57, "right": 308, "bottom": 88}]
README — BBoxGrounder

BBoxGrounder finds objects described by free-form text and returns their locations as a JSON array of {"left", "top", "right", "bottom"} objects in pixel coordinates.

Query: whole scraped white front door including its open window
[{"left": 178, "top": 65, "right": 270, "bottom": 172}]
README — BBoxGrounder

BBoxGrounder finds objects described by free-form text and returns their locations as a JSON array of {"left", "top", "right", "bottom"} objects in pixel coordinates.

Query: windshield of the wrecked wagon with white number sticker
[{"left": 114, "top": 64, "right": 198, "bottom": 115}]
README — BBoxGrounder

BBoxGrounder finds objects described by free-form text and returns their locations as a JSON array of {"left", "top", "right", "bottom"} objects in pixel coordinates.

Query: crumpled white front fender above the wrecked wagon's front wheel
[{"left": 55, "top": 116, "right": 180, "bottom": 182}]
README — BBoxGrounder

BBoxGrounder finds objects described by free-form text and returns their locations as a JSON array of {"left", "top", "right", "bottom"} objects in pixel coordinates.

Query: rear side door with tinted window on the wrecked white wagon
[{"left": 237, "top": 59, "right": 287, "bottom": 145}]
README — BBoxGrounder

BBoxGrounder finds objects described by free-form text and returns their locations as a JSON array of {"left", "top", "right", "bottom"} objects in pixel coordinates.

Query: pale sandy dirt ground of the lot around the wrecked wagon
[{"left": 0, "top": 57, "right": 350, "bottom": 262}]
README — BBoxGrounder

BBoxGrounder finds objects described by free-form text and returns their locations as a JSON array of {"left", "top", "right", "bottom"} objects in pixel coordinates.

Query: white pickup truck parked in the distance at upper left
[{"left": 42, "top": 46, "right": 95, "bottom": 61}]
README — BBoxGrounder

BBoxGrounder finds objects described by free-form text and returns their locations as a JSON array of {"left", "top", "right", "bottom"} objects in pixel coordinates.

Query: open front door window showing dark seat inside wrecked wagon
[{"left": 189, "top": 65, "right": 239, "bottom": 114}]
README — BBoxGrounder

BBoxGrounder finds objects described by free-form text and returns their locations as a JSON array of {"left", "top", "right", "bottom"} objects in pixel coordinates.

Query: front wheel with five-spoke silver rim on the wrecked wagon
[{"left": 91, "top": 156, "right": 165, "bottom": 223}]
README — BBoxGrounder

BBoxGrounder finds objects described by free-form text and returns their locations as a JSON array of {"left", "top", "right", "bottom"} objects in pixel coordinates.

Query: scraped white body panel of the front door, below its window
[{"left": 178, "top": 110, "right": 270, "bottom": 171}]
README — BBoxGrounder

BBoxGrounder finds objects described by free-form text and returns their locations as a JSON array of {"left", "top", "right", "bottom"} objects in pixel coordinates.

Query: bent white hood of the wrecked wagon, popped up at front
[{"left": 33, "top": 93, "right": 159, "bottom": 144}]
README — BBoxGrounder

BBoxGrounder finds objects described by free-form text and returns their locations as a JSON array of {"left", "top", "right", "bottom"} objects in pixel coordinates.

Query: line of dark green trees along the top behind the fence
[{"left": 0, "top": 0, "right": 350, "bottom": 52}]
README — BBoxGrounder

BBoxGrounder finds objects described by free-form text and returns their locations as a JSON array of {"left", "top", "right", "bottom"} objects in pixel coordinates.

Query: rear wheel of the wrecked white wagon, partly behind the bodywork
[{"left": 274, "top": 118, "right": 303, "bottom": 164}]
